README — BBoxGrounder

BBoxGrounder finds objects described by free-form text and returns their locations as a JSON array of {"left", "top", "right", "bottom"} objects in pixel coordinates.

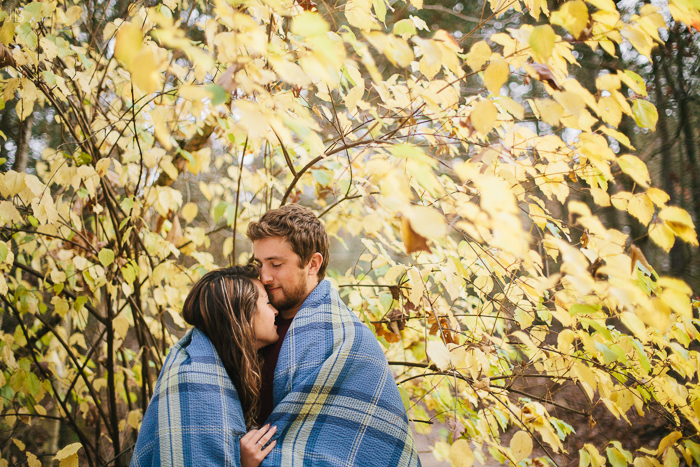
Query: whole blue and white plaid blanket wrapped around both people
[{"left": 131, "top": 281, "right": 420, "bottom": 467}]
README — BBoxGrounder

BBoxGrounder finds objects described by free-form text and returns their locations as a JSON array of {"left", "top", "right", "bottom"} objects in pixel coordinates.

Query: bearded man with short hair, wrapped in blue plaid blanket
[{"left": 247, "top": 205, "right": 420, "bottom": 466}]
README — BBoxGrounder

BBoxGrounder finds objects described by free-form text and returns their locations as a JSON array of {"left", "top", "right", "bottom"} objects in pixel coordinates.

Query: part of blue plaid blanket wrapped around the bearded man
[{"left": 262, "top": 280, "right": 420, "bottom": 467}]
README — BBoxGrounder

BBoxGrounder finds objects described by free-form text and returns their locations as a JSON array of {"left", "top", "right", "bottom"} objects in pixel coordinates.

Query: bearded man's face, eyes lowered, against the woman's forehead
[{"left": 253, "top": 237, "right": 318, "bottom": 318}]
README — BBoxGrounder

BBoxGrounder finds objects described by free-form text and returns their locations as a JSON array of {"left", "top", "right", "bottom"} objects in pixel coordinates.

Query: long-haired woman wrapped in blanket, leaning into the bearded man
[{"left": 131, "top": 265, "right": 278, "bottom": 467}]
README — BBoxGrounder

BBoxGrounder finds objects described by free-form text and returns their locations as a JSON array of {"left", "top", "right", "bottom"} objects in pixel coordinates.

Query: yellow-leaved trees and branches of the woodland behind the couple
[{"left": 0, "top": 0, "right": 700, "bottom": 467}]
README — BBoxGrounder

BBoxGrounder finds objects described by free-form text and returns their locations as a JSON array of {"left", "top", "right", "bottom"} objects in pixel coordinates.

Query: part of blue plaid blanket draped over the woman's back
[{"left": 131, "top": 328, "right": 246, "bottom": 467}]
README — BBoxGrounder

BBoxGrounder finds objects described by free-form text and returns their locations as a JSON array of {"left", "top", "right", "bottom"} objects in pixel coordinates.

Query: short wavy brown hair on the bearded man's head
[{"left": 246, "top": 204, "right": 329, "bottom": 281}]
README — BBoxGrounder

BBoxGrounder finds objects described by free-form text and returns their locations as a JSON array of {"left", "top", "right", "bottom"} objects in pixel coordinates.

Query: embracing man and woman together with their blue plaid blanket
[{"left": 131, "top": 205, "right": 420, "bottom": 467}]
